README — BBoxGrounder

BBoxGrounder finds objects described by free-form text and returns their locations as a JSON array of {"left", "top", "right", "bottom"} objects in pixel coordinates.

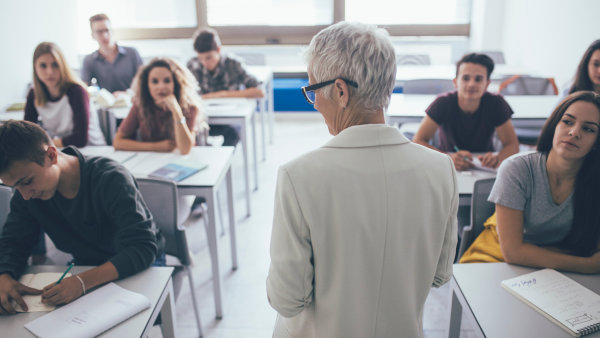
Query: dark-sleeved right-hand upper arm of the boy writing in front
[{"left": 98, "top": 167, "right": 158, "bottom": 278}]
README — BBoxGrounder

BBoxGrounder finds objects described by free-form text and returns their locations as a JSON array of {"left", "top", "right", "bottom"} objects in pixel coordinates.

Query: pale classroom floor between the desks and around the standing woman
[{"left": 45, "top": 113, "right": 474, "bottom": 338}]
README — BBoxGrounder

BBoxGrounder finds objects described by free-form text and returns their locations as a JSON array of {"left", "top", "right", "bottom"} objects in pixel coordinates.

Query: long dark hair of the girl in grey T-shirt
[{"left": 537, "top": 91, "right": 600, "bottom": 256}]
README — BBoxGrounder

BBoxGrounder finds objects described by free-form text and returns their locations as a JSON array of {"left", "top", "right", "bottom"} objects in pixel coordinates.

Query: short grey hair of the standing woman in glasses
[{"left": 305, "top": 22, "right": 396, "bottom": 113}]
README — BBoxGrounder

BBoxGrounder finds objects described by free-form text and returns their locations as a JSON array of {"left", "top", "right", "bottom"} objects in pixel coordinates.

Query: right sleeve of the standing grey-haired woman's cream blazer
[{"left": 432, "top": 156, "right": 458, "bottom": 288}]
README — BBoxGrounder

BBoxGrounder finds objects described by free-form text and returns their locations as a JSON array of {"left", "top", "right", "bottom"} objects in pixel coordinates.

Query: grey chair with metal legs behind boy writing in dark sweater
[{"left": 136, "top": 178, "right": 213, "bottom": 336}]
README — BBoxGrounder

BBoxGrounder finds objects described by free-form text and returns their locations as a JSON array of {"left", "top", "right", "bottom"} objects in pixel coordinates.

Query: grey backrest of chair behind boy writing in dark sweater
[{"left": 136, "top": 178, "right": 191, "bottom": 266}]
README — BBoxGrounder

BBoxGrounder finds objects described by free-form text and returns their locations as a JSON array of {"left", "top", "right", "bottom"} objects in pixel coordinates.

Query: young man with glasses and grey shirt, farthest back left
[{"left": 81, "top": 14, "right": 142, "bottom": 96}]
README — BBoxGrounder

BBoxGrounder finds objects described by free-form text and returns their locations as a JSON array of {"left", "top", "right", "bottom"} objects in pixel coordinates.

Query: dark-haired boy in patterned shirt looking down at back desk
[{"left": 187, "top": 28, "right": 264, "bottom": 146}]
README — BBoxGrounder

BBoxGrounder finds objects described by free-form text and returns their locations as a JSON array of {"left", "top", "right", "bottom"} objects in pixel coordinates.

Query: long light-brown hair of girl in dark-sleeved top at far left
[{"left": 33, "top": 42, "right": 86, "bottom": 107}]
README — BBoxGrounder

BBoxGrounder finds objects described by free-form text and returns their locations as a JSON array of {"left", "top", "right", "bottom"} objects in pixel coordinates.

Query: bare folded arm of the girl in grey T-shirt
[{"left": 496, "top": 204, "right": 600, "bottom": 273}]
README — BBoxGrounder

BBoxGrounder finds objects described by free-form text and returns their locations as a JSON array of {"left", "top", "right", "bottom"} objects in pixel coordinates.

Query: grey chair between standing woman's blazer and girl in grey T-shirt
[{"left": 456, "top": 177, "right": 496, "bottom": 262}]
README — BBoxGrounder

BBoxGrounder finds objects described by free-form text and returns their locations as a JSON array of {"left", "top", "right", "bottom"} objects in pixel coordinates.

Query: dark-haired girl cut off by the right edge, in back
[{"left": 569, "top": 39, "right": 600, "bottom": 94}]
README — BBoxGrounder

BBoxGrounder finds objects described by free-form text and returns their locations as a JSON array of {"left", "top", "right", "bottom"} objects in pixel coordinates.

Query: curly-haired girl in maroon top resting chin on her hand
[{"left": 113, "top": 58, "right": 208, "bottom": 154}]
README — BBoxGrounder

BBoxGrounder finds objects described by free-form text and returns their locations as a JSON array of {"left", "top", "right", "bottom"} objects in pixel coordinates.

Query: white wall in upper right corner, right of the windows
[{"left": 500, "top": 0, "right": 600, "bottom": 88}]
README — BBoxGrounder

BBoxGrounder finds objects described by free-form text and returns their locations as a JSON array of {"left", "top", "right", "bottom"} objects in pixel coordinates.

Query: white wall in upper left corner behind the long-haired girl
[{"left": 0, "top": 0, "right": 78, "bottom": 109}]
